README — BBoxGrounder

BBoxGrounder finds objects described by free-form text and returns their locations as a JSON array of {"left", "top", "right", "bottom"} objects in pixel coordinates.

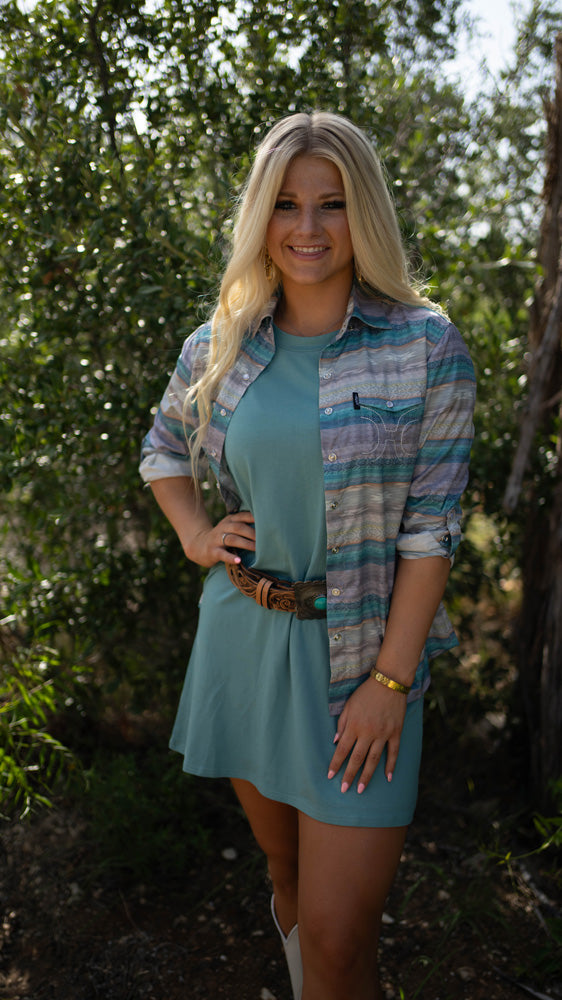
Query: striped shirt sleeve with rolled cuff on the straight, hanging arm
[{"left": 397, "top": 324, "right": 476, "bottom": 563}]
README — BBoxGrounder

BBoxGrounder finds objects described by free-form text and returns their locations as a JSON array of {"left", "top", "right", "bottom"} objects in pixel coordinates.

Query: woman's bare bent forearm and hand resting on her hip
[{"left": 150, "top": 476, "right": 256, "bottom": 567}]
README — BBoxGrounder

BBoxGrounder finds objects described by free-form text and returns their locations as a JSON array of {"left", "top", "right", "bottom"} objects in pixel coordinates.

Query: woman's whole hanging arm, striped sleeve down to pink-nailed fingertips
[{"left": 329, "top": 318, "right": 474, "bottom": 791}]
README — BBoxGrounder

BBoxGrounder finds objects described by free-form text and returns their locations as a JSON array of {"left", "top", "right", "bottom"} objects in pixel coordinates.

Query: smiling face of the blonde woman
[{"left": 266, "top": 155, "right": 353, "bottom": 295}]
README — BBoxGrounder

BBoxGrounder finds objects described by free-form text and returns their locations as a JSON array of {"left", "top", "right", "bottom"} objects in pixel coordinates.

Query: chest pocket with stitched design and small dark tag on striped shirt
[{"left": 353, "top": 393, "right": 424, "bottom": 463}]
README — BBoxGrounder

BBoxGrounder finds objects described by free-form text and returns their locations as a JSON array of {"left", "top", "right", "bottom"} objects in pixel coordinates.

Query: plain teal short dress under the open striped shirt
[{"left": 170, "top": 328, "right": 423, "bottom": 827}]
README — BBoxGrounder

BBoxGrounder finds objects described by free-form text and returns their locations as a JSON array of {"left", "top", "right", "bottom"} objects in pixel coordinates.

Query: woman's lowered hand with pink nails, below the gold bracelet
[{"left": 328, "top": 677, "right": 406, "bottom": 794}]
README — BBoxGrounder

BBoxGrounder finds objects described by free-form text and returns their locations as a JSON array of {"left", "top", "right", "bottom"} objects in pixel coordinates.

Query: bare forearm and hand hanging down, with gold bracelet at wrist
[{"left": 328, "top": 556, "right": 450, "bottom": 793}]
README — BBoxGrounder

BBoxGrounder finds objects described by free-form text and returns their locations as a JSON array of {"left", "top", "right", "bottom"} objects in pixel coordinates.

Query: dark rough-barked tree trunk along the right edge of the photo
[{"left": 504, "top": 35, "right": 562, "bottom": 807}]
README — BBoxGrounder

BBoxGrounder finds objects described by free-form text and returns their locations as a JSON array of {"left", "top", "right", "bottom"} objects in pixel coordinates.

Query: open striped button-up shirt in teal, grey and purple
[{"left": 140, "top": 288, "right": 475, "bottom": 715}]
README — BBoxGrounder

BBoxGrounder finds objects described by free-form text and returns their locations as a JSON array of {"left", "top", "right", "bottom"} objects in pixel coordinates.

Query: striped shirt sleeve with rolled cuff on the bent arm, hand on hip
[{"left": 139, "top": 331, "right": 208, "bottom": 483}]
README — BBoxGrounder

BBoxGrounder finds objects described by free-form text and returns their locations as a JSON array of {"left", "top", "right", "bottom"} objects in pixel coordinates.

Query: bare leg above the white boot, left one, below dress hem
[{"left": 232, "top": 778, "right": 299, "bottom": 935}]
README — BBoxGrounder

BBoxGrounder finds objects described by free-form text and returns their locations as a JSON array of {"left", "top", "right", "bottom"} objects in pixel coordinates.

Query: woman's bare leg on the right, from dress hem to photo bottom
[{"left": 298, "top": 813, "right": 406, "bottom": 1000}]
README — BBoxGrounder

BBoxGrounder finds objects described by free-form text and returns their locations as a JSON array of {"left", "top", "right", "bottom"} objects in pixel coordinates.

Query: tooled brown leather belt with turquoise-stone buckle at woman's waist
[{"left": 225, "top": 563, "right": 327, "bottom": 620}]
